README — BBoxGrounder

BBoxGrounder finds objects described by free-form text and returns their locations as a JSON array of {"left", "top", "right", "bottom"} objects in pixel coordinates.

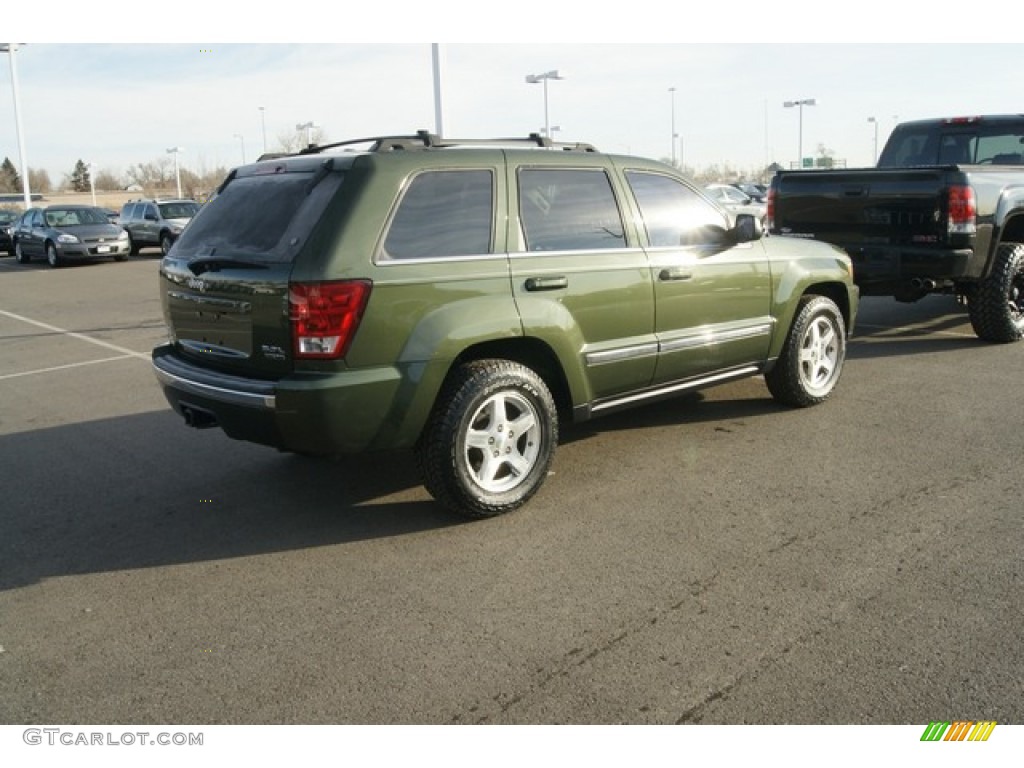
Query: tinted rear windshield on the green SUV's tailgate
[{"left": 167, "top": 171, "right": 343, "bottom": 262}]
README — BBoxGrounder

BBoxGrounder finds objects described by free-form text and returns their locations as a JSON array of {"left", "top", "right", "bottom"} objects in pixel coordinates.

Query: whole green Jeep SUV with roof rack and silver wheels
[{"left": 153, "top": 132, "right": 858, "bottom": 517}]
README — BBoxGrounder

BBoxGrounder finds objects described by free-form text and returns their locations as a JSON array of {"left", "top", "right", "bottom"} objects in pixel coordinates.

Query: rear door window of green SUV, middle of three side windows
[{"left": 519, "top": 168, "right": 626, "bottom": 251}]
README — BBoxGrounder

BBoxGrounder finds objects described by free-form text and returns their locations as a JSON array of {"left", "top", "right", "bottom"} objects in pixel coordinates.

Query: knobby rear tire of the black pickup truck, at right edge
[{"left": 967, "top": 243, "right": 1024, "bottom": 344}]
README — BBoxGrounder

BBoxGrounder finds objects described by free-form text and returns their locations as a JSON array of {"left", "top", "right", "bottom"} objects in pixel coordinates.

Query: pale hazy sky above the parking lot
[{"left": 0, "top": 2, "right": 1024, "bottom": 183}]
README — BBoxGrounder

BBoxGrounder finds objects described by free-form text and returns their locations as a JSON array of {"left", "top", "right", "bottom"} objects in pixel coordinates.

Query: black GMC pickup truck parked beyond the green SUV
[{"left": 766, "top": 115, "right": 1024, "bottom": 342}]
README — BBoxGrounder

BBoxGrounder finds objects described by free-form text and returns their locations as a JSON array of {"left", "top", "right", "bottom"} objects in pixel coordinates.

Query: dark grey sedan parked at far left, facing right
[{"left": 11, "top": 205, "right": 130, "bottom": 267}]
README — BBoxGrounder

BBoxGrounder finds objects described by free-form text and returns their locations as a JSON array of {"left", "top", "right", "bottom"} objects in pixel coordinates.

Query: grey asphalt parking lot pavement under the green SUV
[{"left": 0, "top": 255, "right": 1024, "bottom": 727}]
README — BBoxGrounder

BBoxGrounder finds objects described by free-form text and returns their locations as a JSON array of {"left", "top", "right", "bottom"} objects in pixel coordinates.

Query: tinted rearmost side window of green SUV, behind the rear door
[{"left": 382, "top": 170, "right": 495, "bottom": 259}]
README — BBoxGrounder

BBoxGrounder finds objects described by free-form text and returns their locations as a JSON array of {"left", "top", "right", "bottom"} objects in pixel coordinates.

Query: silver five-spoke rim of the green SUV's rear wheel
[{"left": 461, "top": 392, "right": 541, "bottom": 494}]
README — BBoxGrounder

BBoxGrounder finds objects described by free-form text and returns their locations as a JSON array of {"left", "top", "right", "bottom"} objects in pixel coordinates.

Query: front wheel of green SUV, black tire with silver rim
[{"left": 765, "top": 295, "right": 846, "bottom": 408}]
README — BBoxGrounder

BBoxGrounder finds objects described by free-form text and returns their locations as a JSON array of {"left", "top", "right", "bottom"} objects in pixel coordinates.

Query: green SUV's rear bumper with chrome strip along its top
[{"left": 153, "top": 344, "right": 408, "bottom": 454}]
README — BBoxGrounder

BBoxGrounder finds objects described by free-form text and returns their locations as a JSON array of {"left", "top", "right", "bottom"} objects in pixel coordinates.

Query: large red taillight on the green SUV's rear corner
[{"left": 288, "top": 280, "right": 372, "bottom": 359}]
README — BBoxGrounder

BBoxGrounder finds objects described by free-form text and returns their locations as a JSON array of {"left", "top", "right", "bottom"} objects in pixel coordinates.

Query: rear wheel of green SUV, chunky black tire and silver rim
[{"left": 417, "top": 359, "right": 558, "bottom": 518}]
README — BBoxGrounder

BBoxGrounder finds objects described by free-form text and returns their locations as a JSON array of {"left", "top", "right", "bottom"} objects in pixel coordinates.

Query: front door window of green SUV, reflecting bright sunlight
[{"left": 626, "top": 171, "right": 738, "bottom": 248}]
